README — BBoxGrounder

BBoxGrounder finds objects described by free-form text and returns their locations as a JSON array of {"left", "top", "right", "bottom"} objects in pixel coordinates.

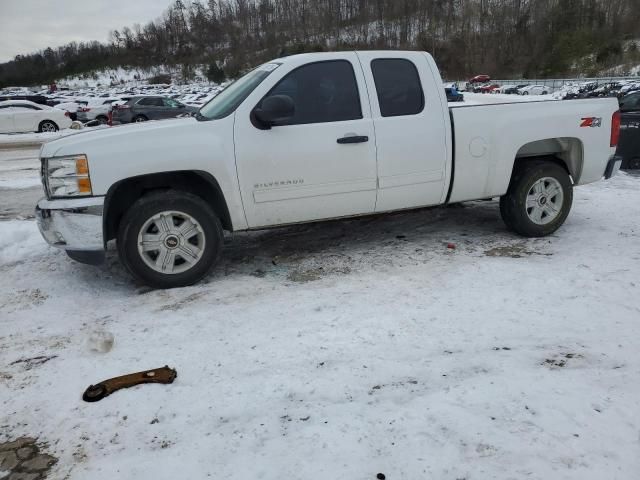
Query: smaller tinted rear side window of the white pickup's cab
[{"left": 371, "top": 58, "right": 424, "bottom": 117}]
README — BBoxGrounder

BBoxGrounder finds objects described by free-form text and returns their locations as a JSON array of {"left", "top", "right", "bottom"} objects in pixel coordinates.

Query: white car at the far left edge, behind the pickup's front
[{"left": 0, "top": 100, "right": 72, "bottom": 133}]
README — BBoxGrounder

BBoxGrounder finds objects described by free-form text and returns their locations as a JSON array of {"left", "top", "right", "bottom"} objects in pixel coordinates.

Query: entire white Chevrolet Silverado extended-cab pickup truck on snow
[{"left": 36, "top": 51, "right": 620, "bottom": 288}]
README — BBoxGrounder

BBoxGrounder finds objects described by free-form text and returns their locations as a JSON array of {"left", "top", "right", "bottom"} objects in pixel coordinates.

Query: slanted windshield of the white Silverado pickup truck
[{"left": 197, "top": 63, "right": 280, "bottom": 120}]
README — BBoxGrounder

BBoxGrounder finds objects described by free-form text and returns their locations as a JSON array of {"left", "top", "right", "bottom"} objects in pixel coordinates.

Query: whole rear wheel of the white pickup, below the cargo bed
[{"left": 500, "top": 160, "right": 573, "bottom": 237}]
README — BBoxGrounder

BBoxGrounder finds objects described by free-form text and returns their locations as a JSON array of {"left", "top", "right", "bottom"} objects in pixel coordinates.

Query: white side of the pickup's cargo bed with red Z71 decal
[{"left": 449, "top": 98, "right": 618, "bottom": 202}]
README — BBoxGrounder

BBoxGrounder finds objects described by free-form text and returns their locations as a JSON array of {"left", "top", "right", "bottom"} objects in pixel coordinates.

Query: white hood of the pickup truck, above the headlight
[{"left": 40, "top": 117, "right": 202, "bottom": 158}]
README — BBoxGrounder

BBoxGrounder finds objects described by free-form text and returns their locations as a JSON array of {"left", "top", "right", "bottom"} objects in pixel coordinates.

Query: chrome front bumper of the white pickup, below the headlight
[{"left": 36, "top": 197, "right": 105, "bottom": 265}]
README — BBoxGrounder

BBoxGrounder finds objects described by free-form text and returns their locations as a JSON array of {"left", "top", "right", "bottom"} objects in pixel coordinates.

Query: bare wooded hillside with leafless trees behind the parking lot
[{"left": 0, "top": 0, "right": 640, "bottom": 87}]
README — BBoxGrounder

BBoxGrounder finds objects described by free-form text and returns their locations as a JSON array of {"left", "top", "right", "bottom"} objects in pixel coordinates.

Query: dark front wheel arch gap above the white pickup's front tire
[{"left": 103, "top": 170, "right": 233, "bottom": 243}]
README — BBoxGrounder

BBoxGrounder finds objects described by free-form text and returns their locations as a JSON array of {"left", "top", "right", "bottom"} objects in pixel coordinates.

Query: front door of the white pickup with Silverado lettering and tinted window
[{"left": 235, "top": 52, "right": 376, "bottom": 228}]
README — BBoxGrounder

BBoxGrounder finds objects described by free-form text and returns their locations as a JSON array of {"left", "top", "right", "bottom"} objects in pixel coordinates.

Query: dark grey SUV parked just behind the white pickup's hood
[{"left": 113, "top": 96, "right": 198, "bottom": 125}]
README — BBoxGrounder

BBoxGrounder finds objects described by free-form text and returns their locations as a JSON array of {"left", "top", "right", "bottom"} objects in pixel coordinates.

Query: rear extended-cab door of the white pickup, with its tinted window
[{"left": 358, "top": 52, "right": 451, "bottom": 212}]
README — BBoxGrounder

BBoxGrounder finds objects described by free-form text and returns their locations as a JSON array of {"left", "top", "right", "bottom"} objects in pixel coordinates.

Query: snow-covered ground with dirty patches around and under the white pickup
[{"left": 0, "top": 147, "right": 640, "bottom": 480}]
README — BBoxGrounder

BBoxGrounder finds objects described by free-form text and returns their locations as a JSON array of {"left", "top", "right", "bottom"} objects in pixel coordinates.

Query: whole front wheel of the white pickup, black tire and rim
[{"left": 117, "top": 190, "right": 224, "bottom": 289}]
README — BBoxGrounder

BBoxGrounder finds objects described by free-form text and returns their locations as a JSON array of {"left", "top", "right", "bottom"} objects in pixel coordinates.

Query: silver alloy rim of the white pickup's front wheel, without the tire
[{"left": 138, "top": 211, "right": 206, "bottom": 275}]
